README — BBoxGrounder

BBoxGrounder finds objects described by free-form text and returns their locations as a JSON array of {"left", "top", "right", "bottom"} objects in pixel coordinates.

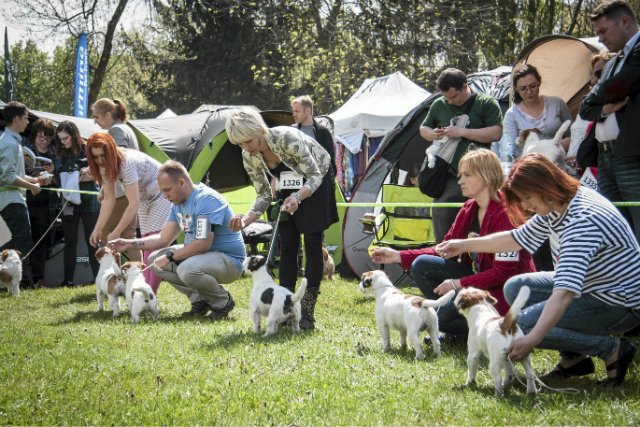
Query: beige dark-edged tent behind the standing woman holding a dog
[{"left": 516, "top": 34, "right": 605, "bottom": 116}]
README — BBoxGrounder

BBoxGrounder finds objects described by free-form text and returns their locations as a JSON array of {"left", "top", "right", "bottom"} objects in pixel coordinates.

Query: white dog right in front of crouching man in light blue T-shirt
[{"left": 122, "top": 261, "right": 160, "bottom": 323}]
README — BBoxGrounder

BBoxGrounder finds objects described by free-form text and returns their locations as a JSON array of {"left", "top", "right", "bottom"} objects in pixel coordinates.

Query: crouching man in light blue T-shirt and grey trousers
[{"left": 109, "top": 160, "right": 245, "bottom": 320}]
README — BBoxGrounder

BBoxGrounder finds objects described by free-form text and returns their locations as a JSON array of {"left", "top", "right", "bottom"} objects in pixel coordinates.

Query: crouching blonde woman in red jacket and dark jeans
[{"left": 371, "top": 149, "right": 535, "bottom": 335}]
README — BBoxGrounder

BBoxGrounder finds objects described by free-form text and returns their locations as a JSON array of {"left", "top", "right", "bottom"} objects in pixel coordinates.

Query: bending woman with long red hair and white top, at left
[{"left": 87, "top": 132, "right": 171, "bottom": 292}]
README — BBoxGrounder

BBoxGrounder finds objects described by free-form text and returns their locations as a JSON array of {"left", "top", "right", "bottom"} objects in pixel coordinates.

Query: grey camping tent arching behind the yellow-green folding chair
[{"left": 342, "top": 67, "right": 511, "bottom": 280}]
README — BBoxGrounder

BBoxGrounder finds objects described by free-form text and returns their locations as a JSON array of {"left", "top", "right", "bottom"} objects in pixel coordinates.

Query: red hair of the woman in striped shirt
[{"left": 502, "top": 153, "right": 580, "bottom": 226}]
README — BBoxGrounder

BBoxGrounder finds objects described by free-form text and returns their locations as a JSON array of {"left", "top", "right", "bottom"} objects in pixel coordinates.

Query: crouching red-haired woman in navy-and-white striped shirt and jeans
[{"left": 438, "top": 154, "right": 640, "bottom": 386}]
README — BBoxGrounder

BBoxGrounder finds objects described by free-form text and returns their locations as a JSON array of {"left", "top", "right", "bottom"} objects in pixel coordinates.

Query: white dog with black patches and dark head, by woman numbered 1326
[{"left": 243, "top": 256, "right": 307, "bottom": 337}]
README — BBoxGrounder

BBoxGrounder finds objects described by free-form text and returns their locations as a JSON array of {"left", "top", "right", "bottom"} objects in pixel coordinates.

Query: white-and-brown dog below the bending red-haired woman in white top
[{"left": 96, "top": 246, "right": 126, "bottom": 317}]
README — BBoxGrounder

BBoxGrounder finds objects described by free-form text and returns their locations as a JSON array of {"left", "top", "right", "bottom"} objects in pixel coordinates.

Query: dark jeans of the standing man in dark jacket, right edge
[{"left": 598, "top": 148, "right": 640, "bottom": 242}]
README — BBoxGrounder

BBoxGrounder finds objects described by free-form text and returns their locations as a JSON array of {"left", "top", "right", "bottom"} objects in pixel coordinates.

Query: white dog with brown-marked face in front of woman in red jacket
[{"left": 359, "top": 270, "right": 455, "bottom": 359}]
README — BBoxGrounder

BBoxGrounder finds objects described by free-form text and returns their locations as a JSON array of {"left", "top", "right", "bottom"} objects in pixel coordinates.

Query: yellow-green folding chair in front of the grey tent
[{"left": 369, "top": 184, "right": 436, "bottom": 285}]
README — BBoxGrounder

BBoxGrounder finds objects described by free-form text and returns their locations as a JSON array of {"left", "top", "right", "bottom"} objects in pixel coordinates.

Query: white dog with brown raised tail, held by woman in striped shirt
[{"left": 455, "top": 286, "right": 537, "bottom": 396}]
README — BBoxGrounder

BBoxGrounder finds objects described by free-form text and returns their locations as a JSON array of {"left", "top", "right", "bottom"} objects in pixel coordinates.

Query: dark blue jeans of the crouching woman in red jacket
[{"left": 411, "top": 255, "right": 473, "bottom": 335}]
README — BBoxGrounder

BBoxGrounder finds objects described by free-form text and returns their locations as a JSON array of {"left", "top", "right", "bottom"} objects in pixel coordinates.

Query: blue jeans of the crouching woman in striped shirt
[{"left": 504, "top": 272, "right": 640, "bottom": 359}]
